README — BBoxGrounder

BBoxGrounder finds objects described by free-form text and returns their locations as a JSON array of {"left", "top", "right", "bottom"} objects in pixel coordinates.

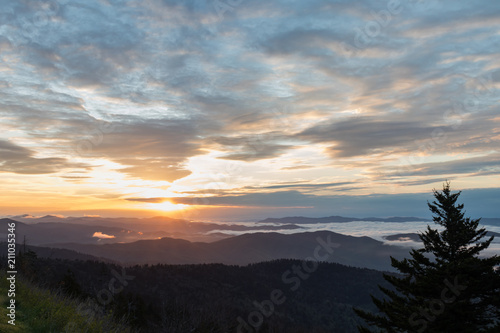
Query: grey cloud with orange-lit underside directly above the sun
[{"left": 84, "top": 117, "right": 203, "bottom": 182}]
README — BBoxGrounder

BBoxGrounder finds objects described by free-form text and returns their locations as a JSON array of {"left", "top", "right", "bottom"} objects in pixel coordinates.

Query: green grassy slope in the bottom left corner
[{"left": 0, "top": 271, "right": 131, "bottom": 333}]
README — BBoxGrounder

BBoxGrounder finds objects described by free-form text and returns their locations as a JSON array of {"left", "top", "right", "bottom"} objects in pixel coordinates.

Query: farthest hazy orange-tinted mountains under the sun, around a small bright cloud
[{"left": 0, "top": 217, "right": 302, "bottom": 245}]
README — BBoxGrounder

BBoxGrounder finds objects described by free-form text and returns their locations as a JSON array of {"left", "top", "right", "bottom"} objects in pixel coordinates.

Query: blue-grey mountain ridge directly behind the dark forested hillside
[{"left": 44, "top": 231, "right": 409, "bottom": 270}]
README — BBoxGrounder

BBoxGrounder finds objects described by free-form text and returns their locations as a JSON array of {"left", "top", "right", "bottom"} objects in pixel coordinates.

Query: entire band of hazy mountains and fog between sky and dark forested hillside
[{"left": 0, "top": 216, "right": 500, "bottom": 270}]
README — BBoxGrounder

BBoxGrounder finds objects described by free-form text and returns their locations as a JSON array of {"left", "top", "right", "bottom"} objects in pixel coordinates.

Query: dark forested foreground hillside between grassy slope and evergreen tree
[{"left": 7, "top": 254, "right": 386, "bottom": 333}]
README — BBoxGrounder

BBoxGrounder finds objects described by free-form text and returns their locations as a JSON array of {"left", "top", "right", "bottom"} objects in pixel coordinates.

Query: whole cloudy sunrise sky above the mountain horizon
[{"left": 0, "top": 0, "right": 500, "bottom": 220}]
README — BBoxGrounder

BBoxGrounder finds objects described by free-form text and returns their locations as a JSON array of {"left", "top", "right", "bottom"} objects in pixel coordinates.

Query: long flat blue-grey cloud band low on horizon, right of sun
[{"left": 168, "top": 187, "right": 500, "bottom": 218}]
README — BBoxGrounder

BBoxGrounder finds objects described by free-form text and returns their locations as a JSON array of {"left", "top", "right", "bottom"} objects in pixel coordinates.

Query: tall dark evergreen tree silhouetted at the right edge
[{"left": 355, "top": 182, "right": 500, "bottom": 333}]
